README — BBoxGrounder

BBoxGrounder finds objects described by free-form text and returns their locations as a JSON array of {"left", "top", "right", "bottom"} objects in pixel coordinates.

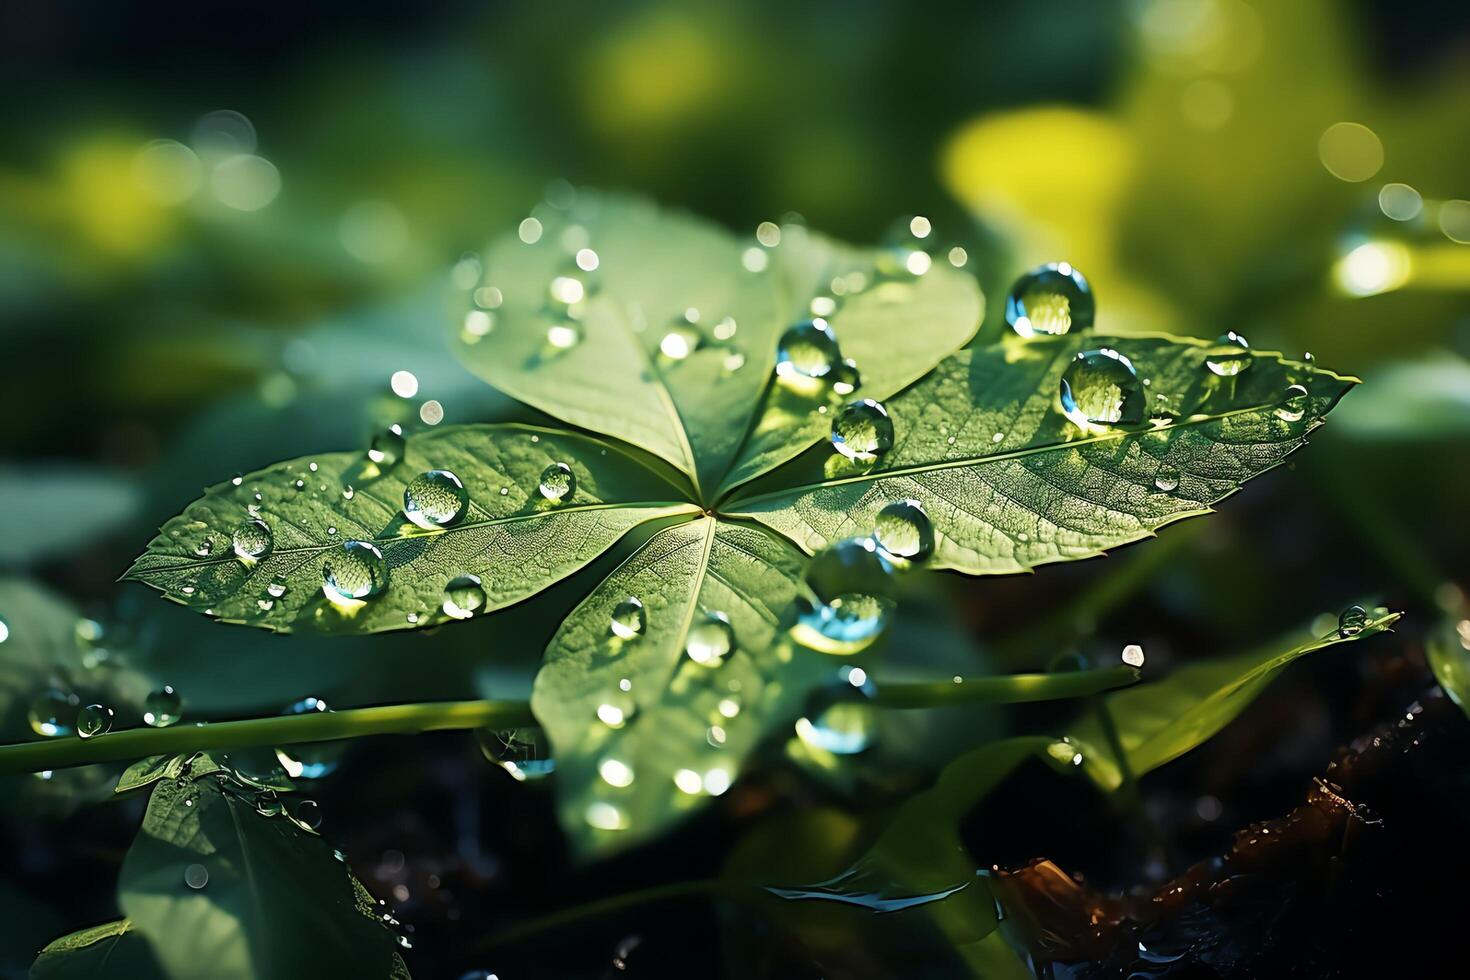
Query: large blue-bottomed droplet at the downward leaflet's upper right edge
[{"left": 791, "top": 538, "right": 894, "bottom": 655}]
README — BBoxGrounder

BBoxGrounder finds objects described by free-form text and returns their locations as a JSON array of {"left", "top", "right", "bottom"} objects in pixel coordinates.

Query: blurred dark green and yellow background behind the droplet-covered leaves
[{"left": 0, "top": 0, "right": 1470, "bottom": 975}]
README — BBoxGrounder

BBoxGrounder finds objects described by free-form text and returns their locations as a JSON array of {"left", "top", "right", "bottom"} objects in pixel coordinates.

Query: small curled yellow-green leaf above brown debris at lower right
[{"left": 1069, "top": 608, "right": 1402, "bottom": 789}]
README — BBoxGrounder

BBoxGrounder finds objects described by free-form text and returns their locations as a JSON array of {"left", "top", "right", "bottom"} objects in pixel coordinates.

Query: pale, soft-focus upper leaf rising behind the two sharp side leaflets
[{"left": 457, "top": 191, "right": 979, "bottom": 500}]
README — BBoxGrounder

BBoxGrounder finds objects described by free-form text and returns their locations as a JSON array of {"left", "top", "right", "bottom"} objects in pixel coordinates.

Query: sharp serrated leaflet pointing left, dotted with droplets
[{"left": 125, "top": 425, "right": 691, "bottom": 633}]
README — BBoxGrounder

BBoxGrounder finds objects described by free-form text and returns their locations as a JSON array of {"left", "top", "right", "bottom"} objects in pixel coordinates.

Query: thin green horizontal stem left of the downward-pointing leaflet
[{"left": 0, "top": 701, "right": 535, "bottom": 773}]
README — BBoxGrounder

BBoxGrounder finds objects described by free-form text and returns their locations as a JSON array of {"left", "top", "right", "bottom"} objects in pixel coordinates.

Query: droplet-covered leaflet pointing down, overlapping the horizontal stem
[{"left": 531, "top": 517, "right": 838, "bottom": 852}]
